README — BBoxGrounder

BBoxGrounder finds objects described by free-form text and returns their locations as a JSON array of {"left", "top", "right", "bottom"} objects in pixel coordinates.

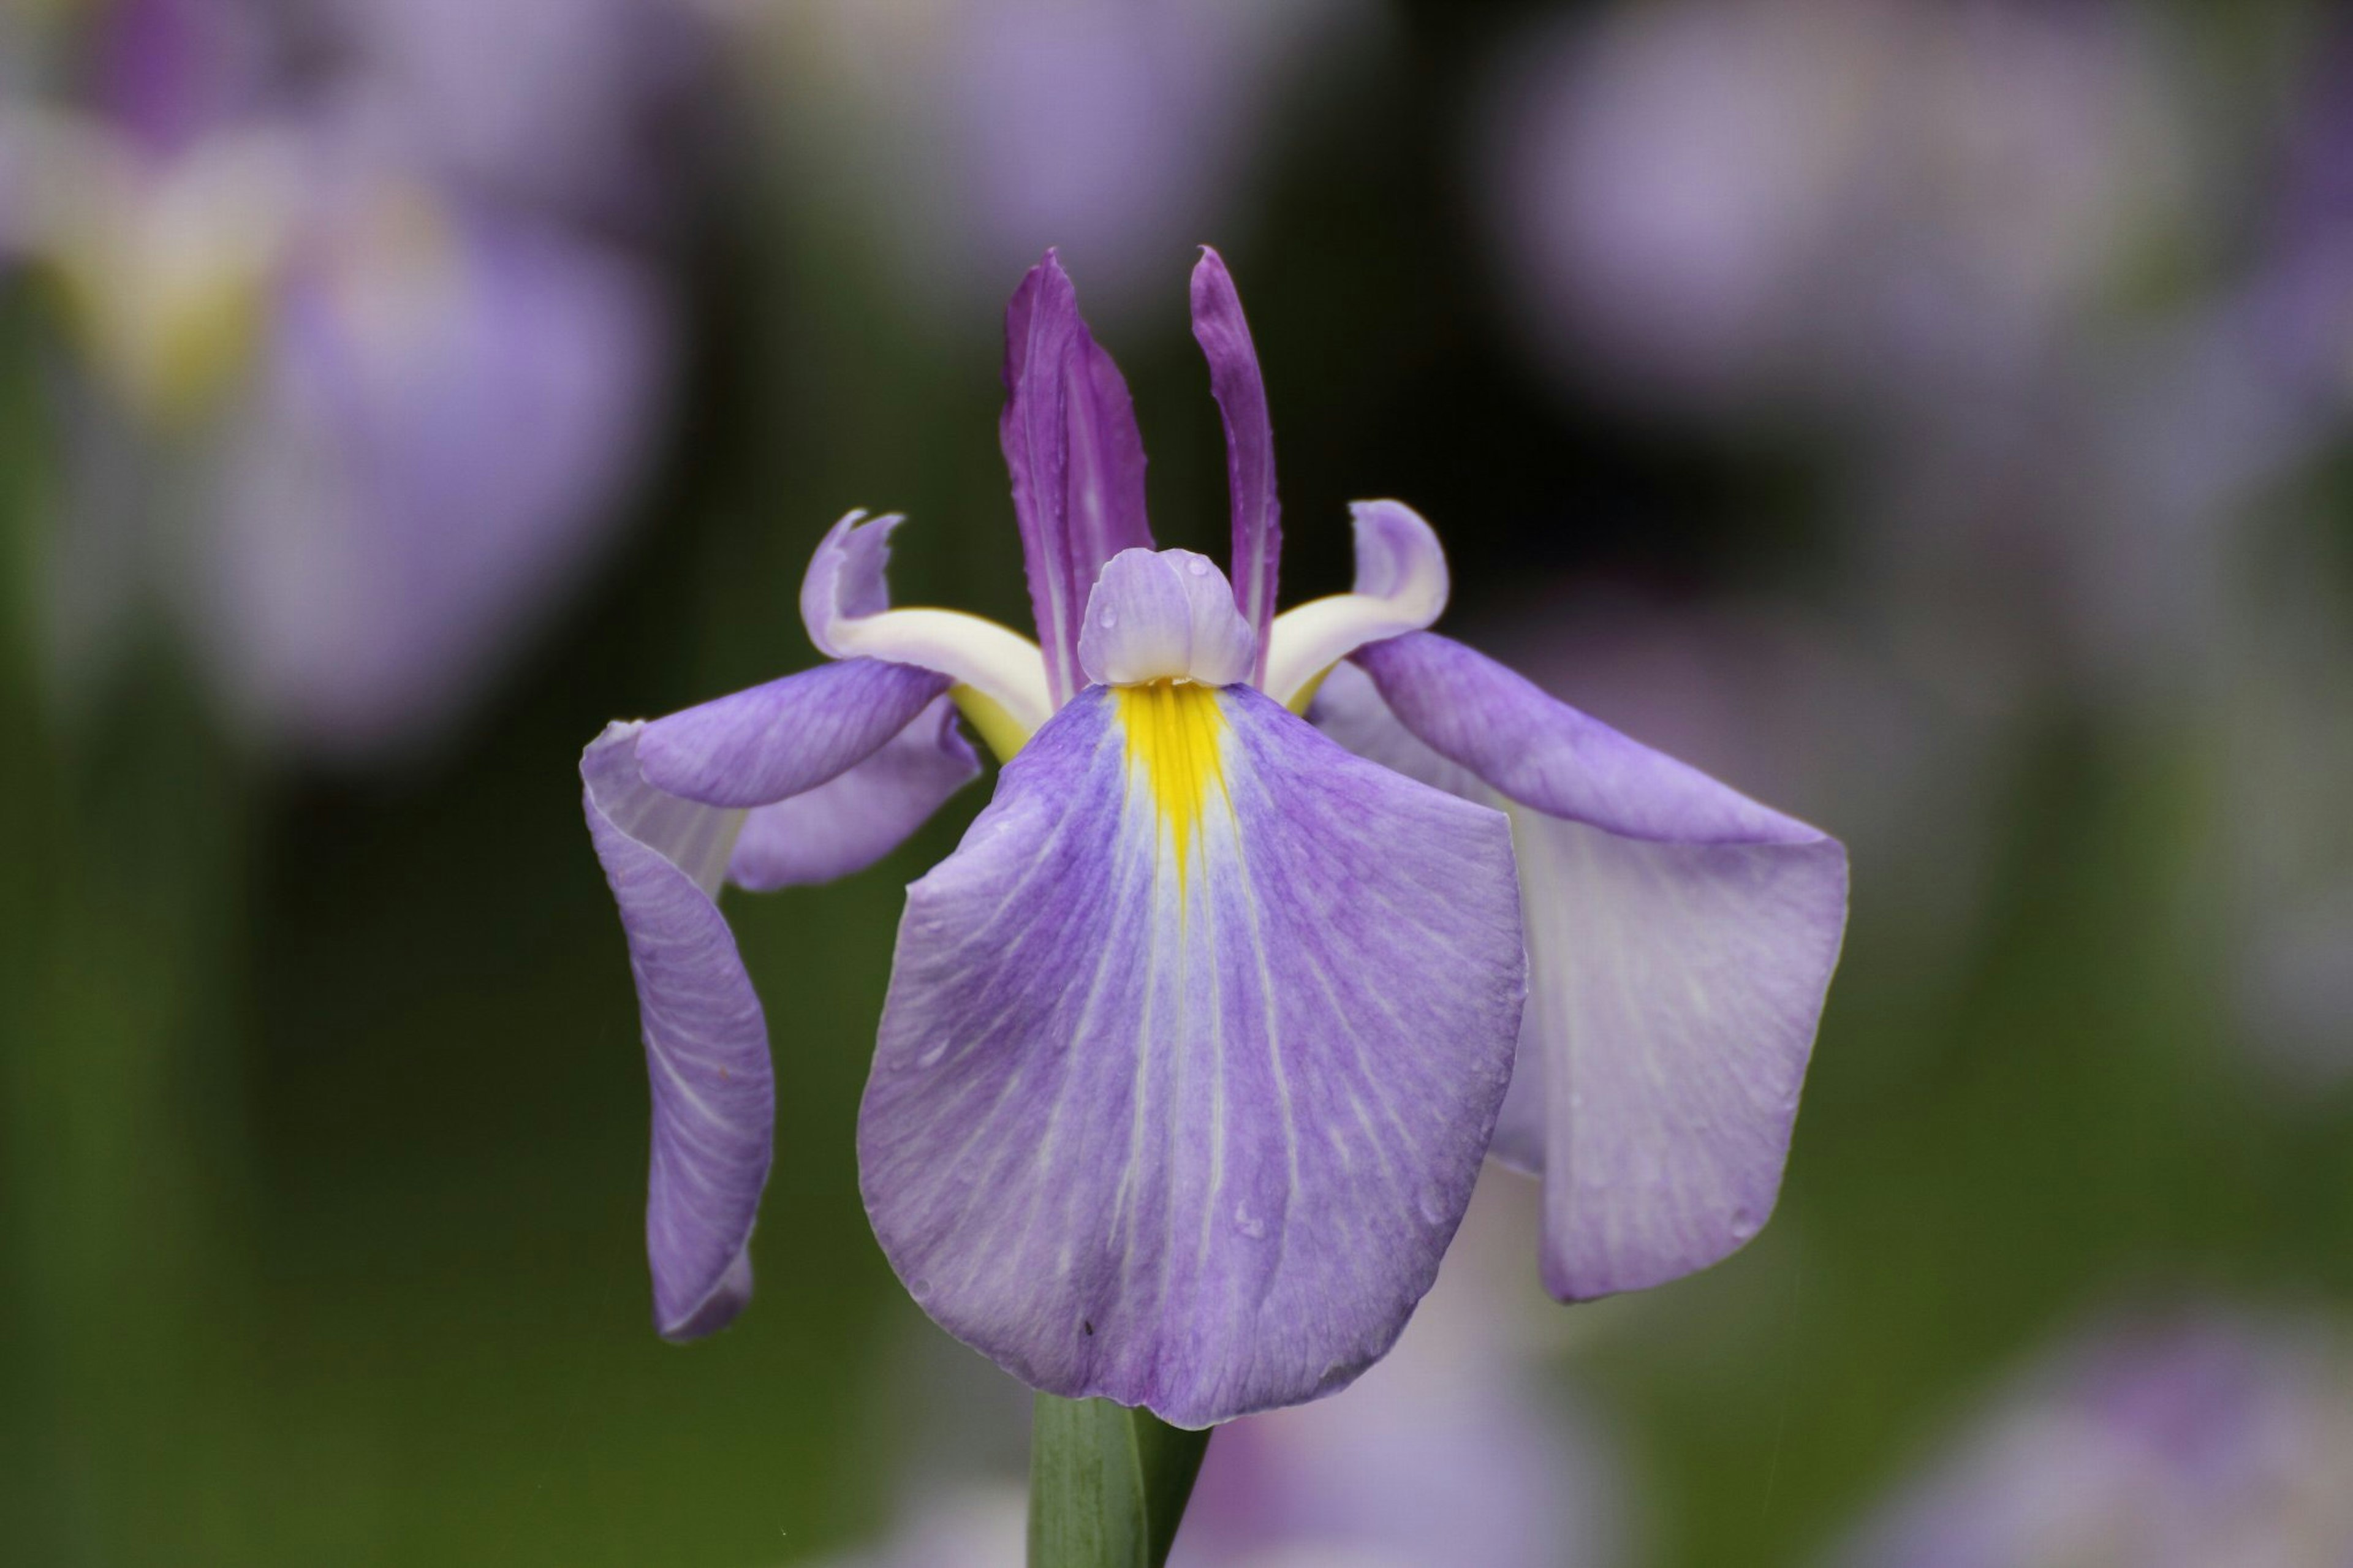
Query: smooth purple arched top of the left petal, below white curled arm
[{"left": 638, "top": 659, "right": 949, "bottom": 805}]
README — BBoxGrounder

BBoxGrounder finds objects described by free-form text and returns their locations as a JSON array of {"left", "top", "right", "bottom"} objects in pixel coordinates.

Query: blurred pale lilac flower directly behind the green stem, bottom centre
[{"left": 840, "top": 1168, "right": 1640, "bottom": 1568}]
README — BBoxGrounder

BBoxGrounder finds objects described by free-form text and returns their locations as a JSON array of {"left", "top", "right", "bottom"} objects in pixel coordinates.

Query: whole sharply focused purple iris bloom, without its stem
[{"left": 581, "top": 252, "right": 1845, "bottom": 1426}]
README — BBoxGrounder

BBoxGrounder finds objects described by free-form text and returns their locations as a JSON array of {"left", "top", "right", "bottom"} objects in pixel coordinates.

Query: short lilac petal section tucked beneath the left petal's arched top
[{"left": 727, "top": 692, "right": 981, "bottom": 892}]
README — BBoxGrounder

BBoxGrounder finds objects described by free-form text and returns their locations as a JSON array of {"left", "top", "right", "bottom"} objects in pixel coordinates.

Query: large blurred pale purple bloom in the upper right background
[{"left": 1487, "top": 0, "right": 2181, "bottom": 407}]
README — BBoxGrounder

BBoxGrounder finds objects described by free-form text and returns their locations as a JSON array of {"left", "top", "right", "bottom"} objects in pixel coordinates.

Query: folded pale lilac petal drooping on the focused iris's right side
[{"left": 1316, "top": 634, "right": 1847, "bottom": 1300}]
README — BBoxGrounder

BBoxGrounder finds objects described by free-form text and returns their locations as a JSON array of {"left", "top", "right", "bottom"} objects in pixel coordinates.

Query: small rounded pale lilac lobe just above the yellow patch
[{"left": 1078, "top": 551, "right": 1257, "bottom": 685}]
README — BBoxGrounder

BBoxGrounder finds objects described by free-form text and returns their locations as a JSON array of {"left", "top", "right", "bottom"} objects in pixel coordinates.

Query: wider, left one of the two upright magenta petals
[{"left": 998, "top": 252, "right": 1153, "bottom": 704}]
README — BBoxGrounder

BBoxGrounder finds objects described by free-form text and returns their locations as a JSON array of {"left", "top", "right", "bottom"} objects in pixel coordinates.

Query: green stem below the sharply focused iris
[{"left": 1028, "top": 1394, "right": 1210, "bottom": 1568}]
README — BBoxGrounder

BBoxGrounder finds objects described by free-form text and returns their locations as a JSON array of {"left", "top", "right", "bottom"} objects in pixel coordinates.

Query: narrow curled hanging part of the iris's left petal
[{"left": 581, "top": 723, "right": 776, "bottom": 1339}]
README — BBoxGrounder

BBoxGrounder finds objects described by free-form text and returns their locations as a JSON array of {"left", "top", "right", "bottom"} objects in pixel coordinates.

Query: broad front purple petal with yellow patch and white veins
[{"left": 859, "top": 683, "right": 1525, "bottom": 1426}]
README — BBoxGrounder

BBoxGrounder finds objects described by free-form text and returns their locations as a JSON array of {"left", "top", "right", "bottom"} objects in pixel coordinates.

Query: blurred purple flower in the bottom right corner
[{"left": 1828, "top": 1311, "right": 2353, "bottom": 1568}]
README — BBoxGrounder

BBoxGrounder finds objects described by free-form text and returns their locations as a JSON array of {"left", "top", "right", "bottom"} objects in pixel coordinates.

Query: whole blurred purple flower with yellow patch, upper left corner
[{"left": 0, "top": 0, "right": 670, "bottom": 754}]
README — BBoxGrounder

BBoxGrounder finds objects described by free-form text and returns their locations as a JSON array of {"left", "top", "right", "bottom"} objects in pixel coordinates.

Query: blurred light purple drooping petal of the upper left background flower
[{"left": 200, "top": 174, "right": 669, "bottom": 754}]
